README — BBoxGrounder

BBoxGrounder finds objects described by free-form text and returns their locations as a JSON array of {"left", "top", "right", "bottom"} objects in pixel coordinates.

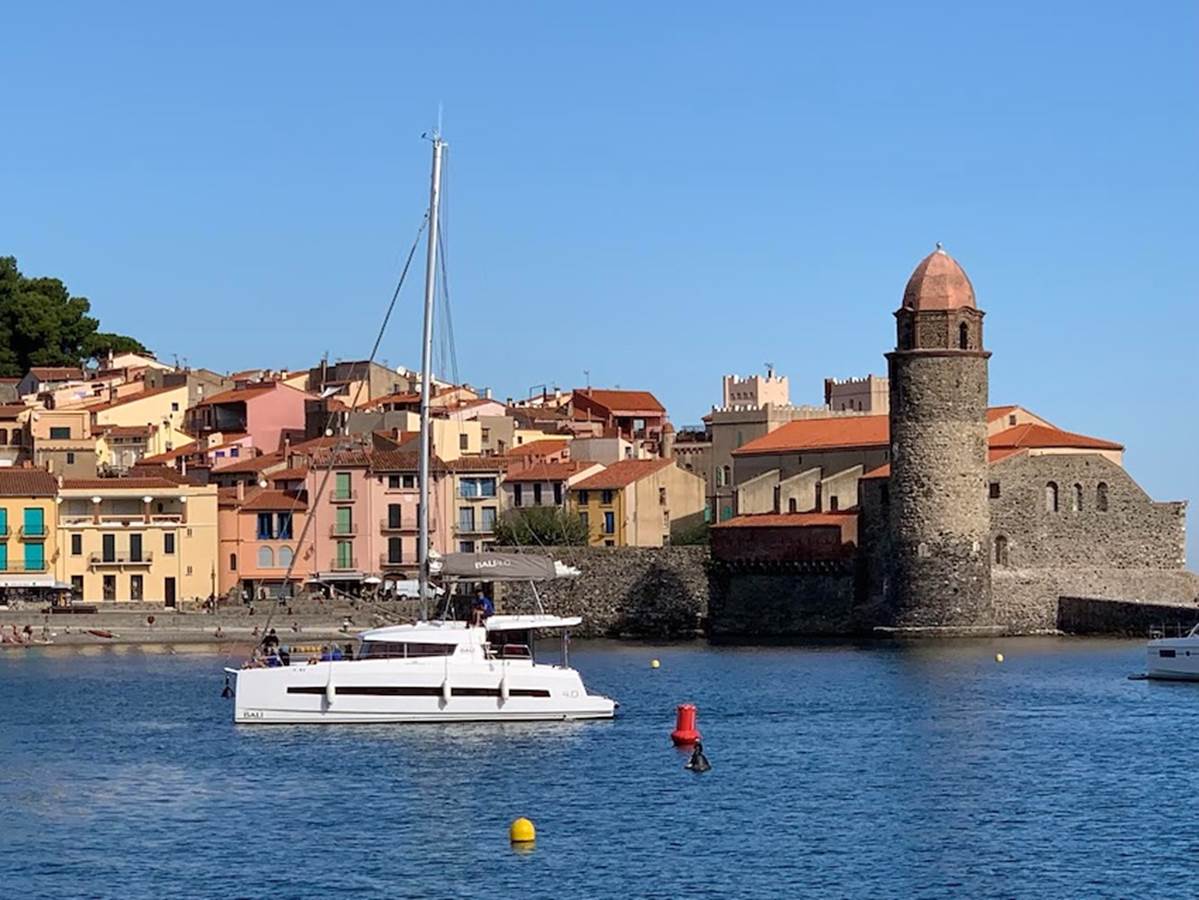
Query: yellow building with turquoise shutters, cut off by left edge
[{"left": 0, "top": 467, "right": 58, "bottom": 604}]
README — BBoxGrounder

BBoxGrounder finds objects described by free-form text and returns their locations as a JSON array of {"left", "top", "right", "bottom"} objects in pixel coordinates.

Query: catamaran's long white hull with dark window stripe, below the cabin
[{"left": 228, "top": 662, "right": 616, "bottom": 725}]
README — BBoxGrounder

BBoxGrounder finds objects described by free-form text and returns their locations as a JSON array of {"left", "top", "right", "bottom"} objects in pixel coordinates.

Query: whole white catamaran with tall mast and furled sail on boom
[{"left": 225, "top": 135, "right": 616, "bottom": 724}]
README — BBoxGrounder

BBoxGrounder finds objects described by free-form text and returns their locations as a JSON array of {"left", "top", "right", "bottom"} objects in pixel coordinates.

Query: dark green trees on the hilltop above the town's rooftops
[{"left": 0, "top": 256, "right": 144, "bottom": 377}]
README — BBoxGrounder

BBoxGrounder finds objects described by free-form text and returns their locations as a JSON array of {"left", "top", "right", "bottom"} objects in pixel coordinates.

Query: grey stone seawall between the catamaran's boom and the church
[{"left": 499, "top": 546, "right": 709, "bottom": 638}]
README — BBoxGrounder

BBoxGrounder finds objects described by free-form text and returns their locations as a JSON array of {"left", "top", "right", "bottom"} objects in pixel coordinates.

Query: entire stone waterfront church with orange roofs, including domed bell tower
[{"left": 711, "top": 246, "right": 1199, "bottom": 634}]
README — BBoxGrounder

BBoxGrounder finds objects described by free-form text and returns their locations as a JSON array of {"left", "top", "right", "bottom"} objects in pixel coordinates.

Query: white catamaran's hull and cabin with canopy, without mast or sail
[{"left": 225, "top": 615, "right": 616, "bottom": 724}]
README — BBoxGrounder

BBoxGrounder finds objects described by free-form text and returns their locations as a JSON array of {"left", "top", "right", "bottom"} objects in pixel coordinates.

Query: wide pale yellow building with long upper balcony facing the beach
[{"left": 56, "top": 477, "right": 217, "bottom": 606}]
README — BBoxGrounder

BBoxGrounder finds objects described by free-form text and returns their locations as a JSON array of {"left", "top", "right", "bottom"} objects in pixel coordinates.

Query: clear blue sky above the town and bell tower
[{"left": 0, "top": 2, "right": 1199, "bottom": 560}]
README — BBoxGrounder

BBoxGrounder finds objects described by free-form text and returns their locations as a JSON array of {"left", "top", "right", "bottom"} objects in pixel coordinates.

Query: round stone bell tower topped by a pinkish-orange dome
[{"left": 887, "top": 244, "right": 994, "bottom": 627}]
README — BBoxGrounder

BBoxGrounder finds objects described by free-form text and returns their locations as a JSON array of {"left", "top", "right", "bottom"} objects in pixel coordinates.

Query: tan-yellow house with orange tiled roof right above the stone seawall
[{"left": 571, "top": 459, "right": 704, "bottom": 546}]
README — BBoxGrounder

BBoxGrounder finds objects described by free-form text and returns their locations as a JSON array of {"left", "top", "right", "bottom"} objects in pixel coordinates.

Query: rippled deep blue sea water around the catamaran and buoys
[{"left": 0, "top": 639, "right": 1199, "bottom": 898}]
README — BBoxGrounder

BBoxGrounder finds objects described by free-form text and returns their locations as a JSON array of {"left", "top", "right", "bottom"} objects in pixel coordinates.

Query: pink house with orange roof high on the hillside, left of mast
[{"left": 186, "top": 381, "right": 314, "bottom": 453}]
